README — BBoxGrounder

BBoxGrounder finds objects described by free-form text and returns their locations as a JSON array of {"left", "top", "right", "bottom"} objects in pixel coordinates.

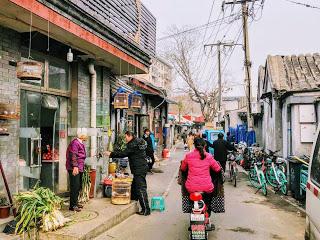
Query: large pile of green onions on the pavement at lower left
[{"left": 15, "top": 187, "right": 68, "bottom": 234}]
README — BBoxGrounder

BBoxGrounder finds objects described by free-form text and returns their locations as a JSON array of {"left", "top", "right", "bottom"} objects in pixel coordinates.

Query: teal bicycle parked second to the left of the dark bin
[{"left": 248, "top": 159, "right": 268, "bottom": 196}]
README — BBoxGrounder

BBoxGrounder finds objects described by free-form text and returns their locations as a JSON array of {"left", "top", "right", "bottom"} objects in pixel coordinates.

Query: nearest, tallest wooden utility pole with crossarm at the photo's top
[{"left": 222, "top": 0, "right": 256, "bottom": 130}]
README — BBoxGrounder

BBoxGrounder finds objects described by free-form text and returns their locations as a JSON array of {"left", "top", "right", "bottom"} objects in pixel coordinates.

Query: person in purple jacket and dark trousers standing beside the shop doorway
[{"left": 66, "top": 133, "right": 88, "bottom": 212}]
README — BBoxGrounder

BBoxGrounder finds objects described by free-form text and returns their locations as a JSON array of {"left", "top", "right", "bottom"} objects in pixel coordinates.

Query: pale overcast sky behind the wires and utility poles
[{"left": 143, "top": 0, "right": 320, "bottom": 96}]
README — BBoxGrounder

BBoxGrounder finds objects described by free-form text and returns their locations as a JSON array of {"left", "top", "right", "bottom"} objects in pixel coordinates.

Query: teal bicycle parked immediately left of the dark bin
[{"left": 265, "top": 150, "right": 288, "bottom": 195}]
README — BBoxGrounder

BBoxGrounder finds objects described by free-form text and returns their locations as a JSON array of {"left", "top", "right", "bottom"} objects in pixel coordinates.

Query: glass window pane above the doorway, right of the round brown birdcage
[{"left": 48, "top": 60, "right": 69, "bottom": 91}]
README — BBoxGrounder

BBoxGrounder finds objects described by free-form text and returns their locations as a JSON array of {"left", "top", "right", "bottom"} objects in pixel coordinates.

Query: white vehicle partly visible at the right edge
[{"left": 305, "top": 127, "right": 320, "bottom": 240}]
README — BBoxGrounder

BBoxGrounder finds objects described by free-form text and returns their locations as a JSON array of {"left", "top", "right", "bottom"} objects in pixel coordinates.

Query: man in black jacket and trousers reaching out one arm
[{"left": 106, "top": 131, "right": 150, "bottom": 216}]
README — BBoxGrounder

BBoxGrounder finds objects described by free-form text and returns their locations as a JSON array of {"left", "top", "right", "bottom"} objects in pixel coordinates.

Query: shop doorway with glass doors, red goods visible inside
[{"left": 19, "top": 90, "right": 67, "bottom": 192}]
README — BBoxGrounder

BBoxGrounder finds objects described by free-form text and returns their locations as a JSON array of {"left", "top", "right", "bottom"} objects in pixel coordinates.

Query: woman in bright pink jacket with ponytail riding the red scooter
[{"left": 181, "top": 138, "right": 221, "bottom": 215}]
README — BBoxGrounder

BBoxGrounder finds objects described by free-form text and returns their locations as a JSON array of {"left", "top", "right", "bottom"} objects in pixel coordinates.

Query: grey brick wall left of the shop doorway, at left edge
[{"left": 0, "top": 26, "right": 20, "bottom": 192}]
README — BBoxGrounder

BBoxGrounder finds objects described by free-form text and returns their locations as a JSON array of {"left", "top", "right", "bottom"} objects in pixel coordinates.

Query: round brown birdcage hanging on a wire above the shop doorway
[{"left": 17, "top": 61, "right": 43, "bottom": 81}]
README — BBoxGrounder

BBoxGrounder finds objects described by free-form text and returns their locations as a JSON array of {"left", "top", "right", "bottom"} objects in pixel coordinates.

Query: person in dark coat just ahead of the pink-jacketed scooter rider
[{"left": 212, "top": 133, "right": 237, "bottom": 171}]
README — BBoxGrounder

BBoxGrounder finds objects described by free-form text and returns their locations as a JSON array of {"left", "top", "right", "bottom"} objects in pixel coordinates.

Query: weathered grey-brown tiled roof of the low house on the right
[{"left": 267, "top": 53, "right": 320, "bottom": 95}]
